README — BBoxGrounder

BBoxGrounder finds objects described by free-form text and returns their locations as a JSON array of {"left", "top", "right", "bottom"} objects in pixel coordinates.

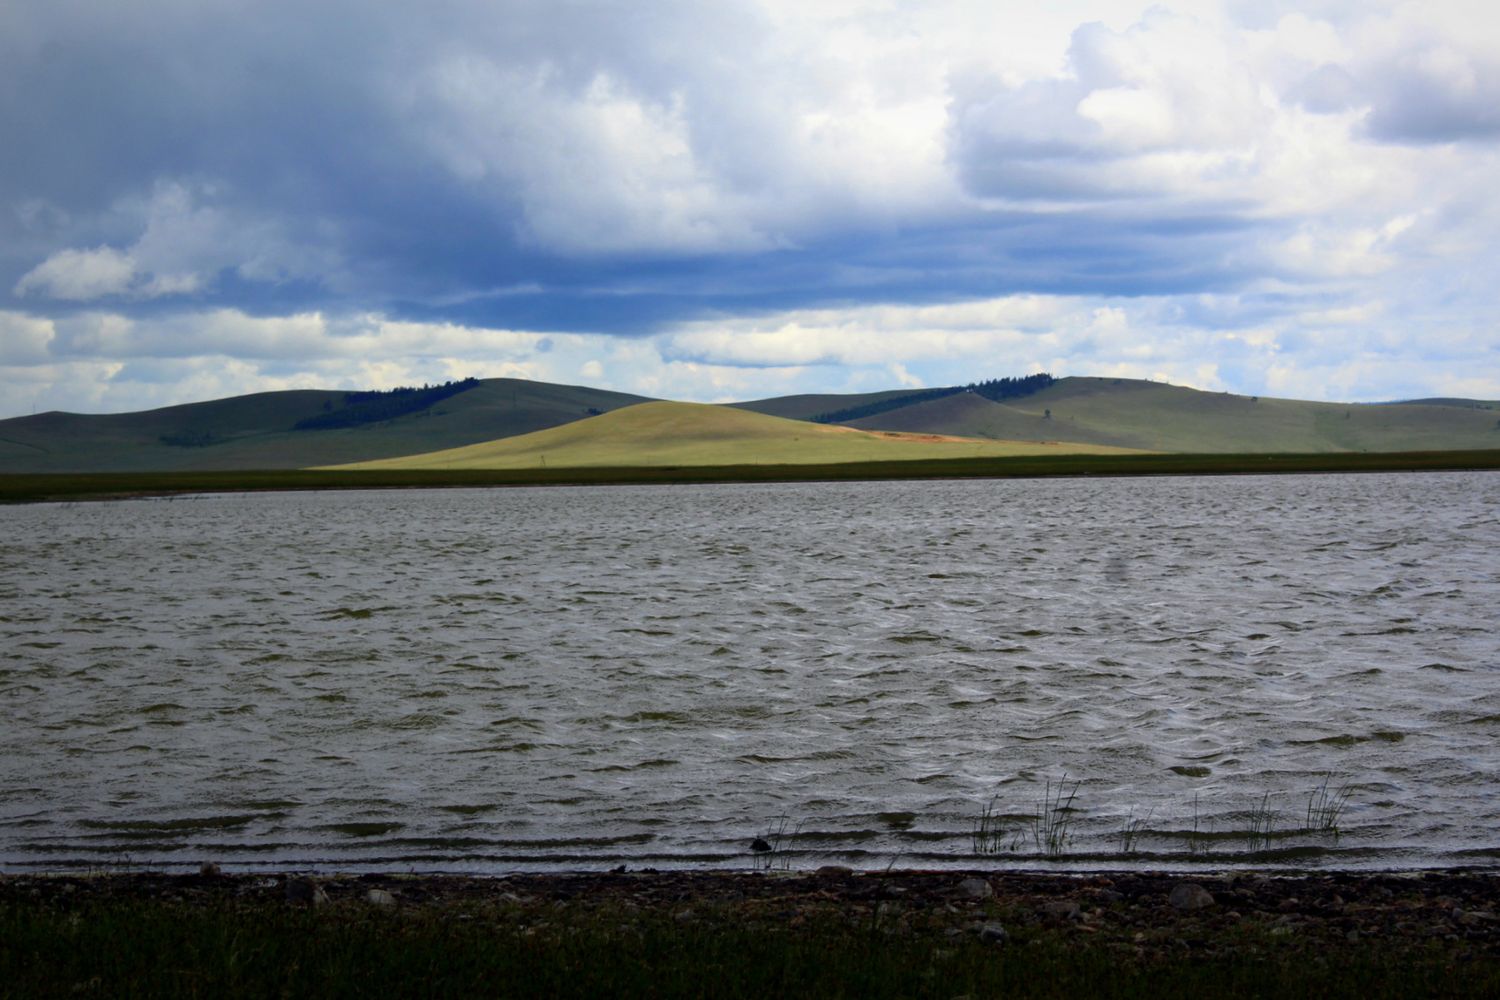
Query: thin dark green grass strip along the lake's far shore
[{"left": 0, "top": 450, "right": 1500, "bottom": 504}]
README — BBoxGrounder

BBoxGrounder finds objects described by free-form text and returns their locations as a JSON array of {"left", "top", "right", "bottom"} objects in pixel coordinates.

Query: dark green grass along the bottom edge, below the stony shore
[{"left": 0, "top": 901, "right": 1500, "bottom": 1000}]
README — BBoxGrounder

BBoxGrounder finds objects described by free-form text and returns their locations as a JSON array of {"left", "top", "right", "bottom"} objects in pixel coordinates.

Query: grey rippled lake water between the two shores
[{"left": 0, "top": 472, "right": 1500, "bottom": 871}]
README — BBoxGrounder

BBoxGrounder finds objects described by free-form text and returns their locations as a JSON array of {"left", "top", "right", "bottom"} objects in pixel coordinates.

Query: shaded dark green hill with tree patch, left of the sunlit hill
[{"left": 0, "top": 378, "right": 645, "bottom": 472}]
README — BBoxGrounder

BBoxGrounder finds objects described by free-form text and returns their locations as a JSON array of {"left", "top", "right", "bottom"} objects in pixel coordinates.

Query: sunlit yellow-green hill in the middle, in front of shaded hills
[{"left": 331, "top": 402, "right": 1146, "bottom": 469}]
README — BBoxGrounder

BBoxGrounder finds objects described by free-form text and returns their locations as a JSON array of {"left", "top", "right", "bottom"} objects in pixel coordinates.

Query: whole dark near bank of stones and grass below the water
[{"left": 0, "top": 870, "right": 1500, "bottom": 1000}]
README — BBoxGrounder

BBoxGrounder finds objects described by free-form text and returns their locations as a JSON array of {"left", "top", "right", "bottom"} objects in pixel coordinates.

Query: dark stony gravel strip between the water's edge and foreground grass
[{"left": 0, "top": 867, "right": 1500, "bottom": 960}]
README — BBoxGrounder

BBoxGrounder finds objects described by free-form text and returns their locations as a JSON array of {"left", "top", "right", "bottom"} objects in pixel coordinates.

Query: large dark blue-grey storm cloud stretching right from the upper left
[{"left": 0, "top": 0, "right": 1290, "bottom": 333}]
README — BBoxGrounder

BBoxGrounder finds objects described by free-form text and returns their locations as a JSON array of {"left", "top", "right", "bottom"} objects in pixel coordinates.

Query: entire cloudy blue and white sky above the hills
[{"left": 0, "top": 0, "right": 1500, "bottom": 417}]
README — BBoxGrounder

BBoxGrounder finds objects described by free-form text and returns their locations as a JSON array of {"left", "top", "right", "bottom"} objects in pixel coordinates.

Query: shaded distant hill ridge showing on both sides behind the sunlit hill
[{"left": 0, "top": 375, "right": 1500, "bottom": 474}]
